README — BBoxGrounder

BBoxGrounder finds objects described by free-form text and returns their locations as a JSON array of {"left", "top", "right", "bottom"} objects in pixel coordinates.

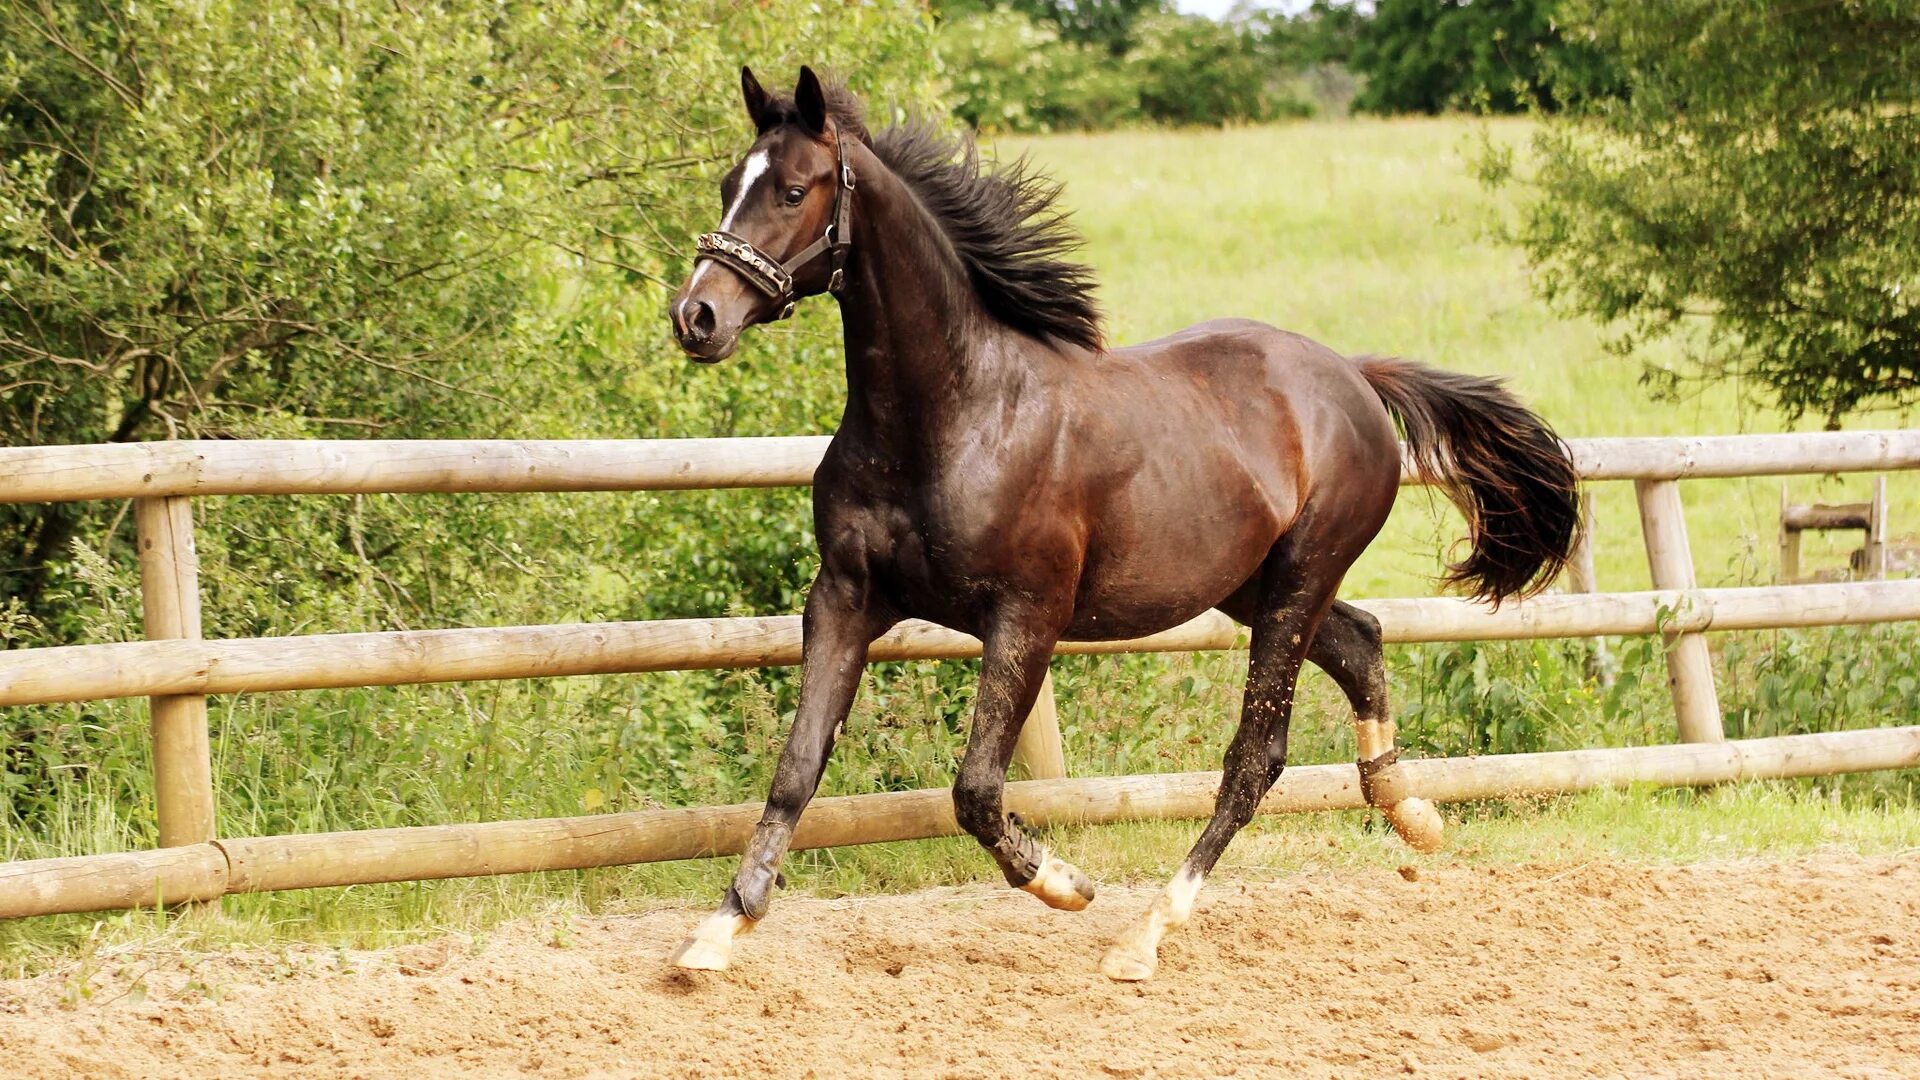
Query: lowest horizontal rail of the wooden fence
[{"left": 0, "top": 726, "right": 1920, "bottom": 919}]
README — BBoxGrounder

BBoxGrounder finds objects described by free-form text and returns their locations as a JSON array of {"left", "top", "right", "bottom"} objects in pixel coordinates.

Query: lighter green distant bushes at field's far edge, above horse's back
[{"left": 939, "top": 8, "right": 1313, "bottom": 131}]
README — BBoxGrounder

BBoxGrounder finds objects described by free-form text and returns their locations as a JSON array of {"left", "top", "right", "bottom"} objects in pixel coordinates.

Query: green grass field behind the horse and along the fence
[{"left": 0, "top": 119, "right": 1920, "bottom": 957}]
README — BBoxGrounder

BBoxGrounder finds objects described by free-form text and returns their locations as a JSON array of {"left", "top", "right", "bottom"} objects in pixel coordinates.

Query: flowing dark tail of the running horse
[{"left": 1359, "top": 357, "right": 1580, "bottom": 605}]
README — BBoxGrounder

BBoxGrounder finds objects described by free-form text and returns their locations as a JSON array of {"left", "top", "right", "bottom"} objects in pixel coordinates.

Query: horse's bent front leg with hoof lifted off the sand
[{"left": 954, "top": 611, "right": 1092, "bottom": 911}]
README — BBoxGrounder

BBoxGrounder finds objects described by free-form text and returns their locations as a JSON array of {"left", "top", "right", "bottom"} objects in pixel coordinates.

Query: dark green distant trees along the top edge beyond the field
[{"left": 1351, "top": 0, "right": 1613, "bottom": 113}]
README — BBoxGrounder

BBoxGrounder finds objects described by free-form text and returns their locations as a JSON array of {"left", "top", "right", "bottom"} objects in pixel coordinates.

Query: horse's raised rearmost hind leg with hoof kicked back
[{"left": 1308, "top": 601, "right": 1444, "bottom": 851}]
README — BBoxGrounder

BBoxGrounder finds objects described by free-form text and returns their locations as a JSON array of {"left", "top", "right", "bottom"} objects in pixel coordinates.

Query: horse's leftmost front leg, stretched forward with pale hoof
[{"left": 672, "top": 569, "right": 895, "bottom": 970}]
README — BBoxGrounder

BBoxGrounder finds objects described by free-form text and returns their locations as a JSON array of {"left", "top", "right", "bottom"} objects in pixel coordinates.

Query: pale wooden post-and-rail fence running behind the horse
[{"left": 0, "top": 430, "right": 1920, "bottom": 917}]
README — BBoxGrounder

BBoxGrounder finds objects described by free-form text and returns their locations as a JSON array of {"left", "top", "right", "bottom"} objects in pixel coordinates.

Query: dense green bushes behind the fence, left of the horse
[{"left": 0, "top": 0, "right": 935, "bottom": 834}]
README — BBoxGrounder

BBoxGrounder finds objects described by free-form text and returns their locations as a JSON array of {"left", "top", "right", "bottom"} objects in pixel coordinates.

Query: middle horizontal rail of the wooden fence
[{"left": 0, "top": 580, "right": 1920, "bottom": 705}]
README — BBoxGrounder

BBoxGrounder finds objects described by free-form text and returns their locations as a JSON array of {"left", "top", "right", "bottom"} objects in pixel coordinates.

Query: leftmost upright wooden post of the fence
[{"left": 132, "top": 496, "right": 213, "bottom": 847}]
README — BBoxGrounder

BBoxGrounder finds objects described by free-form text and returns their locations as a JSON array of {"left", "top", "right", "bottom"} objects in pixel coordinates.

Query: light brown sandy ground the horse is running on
[{"left": 0, "top": 851, "right": 1920, "bottom": 1080}]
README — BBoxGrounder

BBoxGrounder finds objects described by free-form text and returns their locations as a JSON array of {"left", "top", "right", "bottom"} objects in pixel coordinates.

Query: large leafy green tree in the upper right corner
[{"left": 1486, "top": 0, "right": 1920, "bottom": 425}]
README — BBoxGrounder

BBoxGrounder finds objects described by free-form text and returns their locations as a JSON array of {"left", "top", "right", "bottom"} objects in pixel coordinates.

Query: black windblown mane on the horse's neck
[{"left": 770, "top": 83, "right": 1102, "bottom": 352}]
